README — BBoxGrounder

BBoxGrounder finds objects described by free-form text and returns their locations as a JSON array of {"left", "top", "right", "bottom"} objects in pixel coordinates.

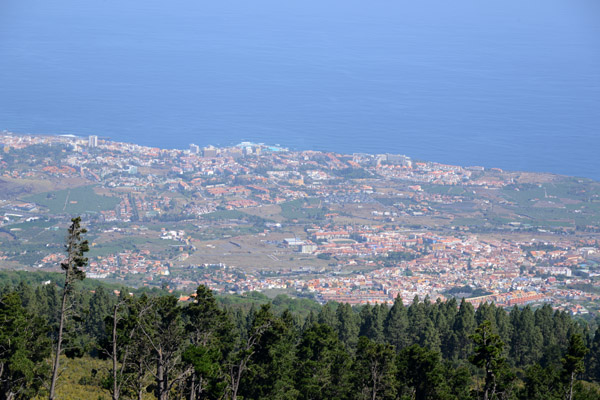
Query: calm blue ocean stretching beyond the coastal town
[{"left": 0, "top": 0, "right": 600, "bottom": 180}]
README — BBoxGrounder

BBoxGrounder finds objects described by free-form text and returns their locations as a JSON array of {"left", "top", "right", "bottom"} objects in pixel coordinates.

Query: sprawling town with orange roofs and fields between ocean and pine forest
[{"left": 0, "top": 132, "right": 600, "bottom": 315}]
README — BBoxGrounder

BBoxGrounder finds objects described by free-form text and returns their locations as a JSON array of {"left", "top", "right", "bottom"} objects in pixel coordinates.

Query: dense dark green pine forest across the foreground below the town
[{"left": 0, "top": 268, "right": 600, "bottom": 400}]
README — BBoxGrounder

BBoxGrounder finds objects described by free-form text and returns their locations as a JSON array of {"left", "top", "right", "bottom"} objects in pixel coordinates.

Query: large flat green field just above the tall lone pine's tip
[{"left": 21, "top": 186, "right": 120, "bottom": 215}]
